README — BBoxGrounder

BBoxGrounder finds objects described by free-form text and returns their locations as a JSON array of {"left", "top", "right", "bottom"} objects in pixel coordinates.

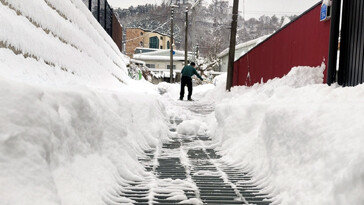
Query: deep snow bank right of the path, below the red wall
[{"left": 204, "top": 67, "right": 364, "bottom": 205}]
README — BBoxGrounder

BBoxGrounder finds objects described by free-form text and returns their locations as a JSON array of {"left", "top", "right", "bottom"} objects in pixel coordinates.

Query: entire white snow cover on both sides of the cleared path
[{"left": 0, "top": 0, "right": 364, "bottom": 205}]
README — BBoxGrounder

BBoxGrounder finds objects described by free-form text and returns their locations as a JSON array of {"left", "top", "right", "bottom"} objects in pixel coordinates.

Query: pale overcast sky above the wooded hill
[{"left": 108, "top": 0, "right": 320, "bottom": 18}]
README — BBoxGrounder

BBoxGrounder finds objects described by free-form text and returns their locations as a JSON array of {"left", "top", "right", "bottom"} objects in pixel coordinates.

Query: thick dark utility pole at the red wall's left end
[{"left": 226, "top": 0, "right": 239, "bottom": 91}]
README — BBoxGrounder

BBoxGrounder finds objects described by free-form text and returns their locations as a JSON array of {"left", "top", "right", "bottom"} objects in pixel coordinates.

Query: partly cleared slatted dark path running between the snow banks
[{"left": 110, "top": 103, "right": 271, "bottom": 205}]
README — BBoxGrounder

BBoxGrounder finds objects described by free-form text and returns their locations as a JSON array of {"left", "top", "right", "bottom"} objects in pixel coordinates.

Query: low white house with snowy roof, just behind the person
[{"left": 132, "top": 47, "right": 192, "bottom": 81}]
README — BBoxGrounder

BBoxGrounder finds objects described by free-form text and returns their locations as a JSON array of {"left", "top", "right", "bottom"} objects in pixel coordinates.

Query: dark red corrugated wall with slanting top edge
[{"left": 233, "top": 4, "right": 330, "bottom": 86}]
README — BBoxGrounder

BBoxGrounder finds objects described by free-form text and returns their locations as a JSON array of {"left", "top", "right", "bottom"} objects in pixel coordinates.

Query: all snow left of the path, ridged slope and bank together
[{"left": 0, "top": 0, "right": 168, "bottom": 205}]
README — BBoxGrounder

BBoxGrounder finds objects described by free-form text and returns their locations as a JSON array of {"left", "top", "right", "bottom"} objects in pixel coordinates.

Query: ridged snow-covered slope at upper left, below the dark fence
[{"left": 0, "top": 0, "right": 129, "bottom": 88}]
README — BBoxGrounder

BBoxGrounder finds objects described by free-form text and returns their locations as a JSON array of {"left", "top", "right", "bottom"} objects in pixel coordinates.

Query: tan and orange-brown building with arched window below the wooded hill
[{"left": 125, "top": 28, "right": 172, "bottom": 57}]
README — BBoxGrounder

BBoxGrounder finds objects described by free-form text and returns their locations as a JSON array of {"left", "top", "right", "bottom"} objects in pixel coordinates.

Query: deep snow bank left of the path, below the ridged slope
[{"left": 0, "top": 76, "right": 168, "bottom": 204}]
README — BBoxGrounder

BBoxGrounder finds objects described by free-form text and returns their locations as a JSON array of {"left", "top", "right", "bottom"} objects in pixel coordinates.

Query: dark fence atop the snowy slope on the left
[{"left": 82, "top": 0, "right": 123, "bottom": 51}]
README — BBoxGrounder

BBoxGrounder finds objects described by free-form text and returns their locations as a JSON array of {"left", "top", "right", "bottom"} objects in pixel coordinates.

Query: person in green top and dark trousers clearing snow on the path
[{"left": 179, "top": 62, "right": 203, "bottom": 101}]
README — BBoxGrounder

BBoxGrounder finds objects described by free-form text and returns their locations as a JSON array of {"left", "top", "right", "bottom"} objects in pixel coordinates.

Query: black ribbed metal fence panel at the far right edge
[{"left": 338, "top": 0, "right": 364, "bottom": 86}]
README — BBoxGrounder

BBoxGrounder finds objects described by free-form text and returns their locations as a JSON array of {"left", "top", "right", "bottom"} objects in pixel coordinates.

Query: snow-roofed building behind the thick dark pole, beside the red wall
[{"left": 217, "top": 35, "right": 270, "bottom": 72}]
